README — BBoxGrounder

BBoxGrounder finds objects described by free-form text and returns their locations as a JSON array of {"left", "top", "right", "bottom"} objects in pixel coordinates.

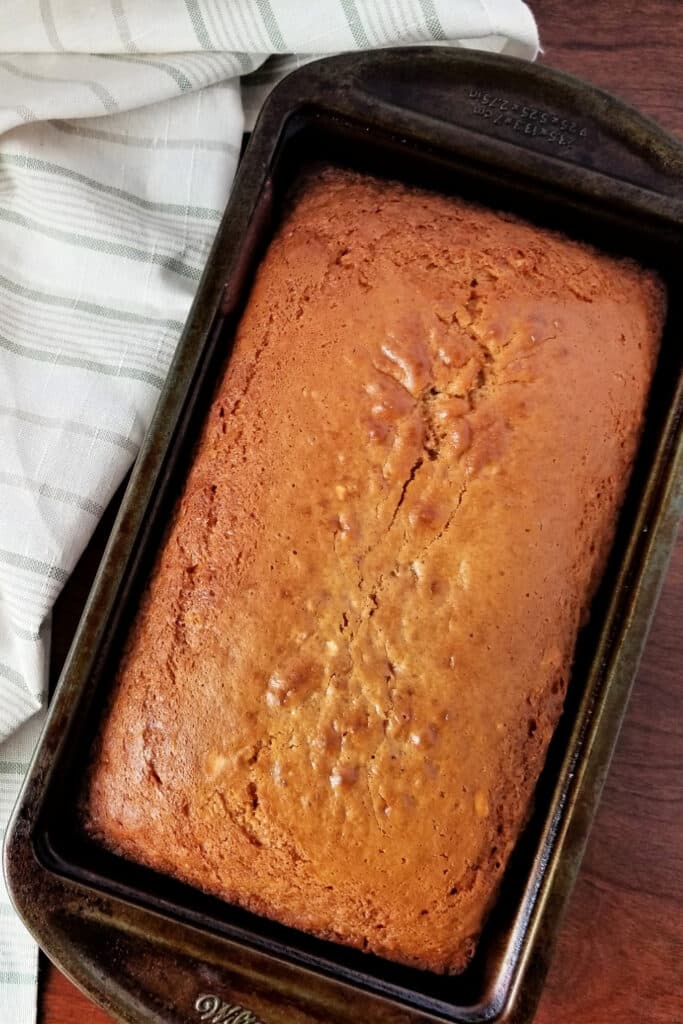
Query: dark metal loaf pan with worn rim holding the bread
[{"left": 5, "top": 48, "right": 683, "bottom": 1024}]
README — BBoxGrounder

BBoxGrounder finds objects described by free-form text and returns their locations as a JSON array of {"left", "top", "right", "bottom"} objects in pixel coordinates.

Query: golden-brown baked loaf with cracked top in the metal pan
[{"left": 85, "top": 169, "right": 664, "bottom": 972}]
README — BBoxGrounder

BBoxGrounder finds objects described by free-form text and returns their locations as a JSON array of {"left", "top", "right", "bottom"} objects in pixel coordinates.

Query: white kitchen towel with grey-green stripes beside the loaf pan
[{"left": 0, "top": 0, "right": 538, "bottom": 1024}]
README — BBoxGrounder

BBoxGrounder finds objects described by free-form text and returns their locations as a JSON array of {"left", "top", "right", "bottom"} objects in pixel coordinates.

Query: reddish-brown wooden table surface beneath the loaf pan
[{"left": 39, "top": 0, "right": 683, "bottom": 1024}]
